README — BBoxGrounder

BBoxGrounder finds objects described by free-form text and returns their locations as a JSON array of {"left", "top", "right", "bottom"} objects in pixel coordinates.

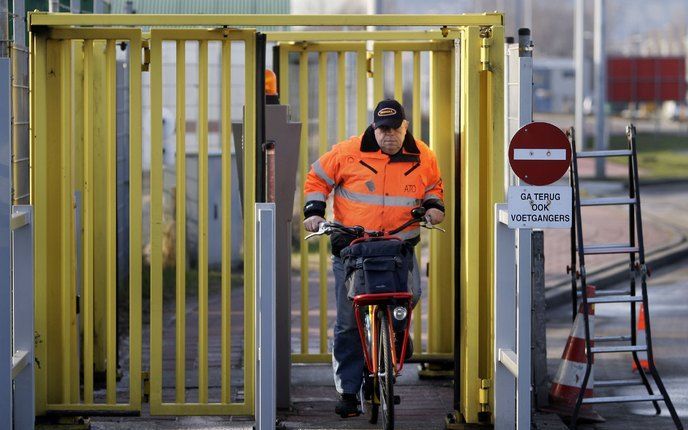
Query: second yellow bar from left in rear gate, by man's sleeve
[{"left": 299, "top": 51, "right": 309, "bottom": 354}]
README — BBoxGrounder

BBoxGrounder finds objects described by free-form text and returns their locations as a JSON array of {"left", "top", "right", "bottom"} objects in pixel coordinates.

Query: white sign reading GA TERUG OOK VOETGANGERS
[{"left": 507, "top": 186, "right": 573, "bottom": 228}]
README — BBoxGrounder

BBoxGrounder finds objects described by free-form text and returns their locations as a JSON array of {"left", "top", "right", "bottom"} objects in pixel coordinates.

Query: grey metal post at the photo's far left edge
[{"left": 0, "top": 58, "right": 13, "bottom": 429}]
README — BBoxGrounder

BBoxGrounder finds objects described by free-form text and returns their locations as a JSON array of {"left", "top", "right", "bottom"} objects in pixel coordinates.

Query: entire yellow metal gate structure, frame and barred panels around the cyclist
[{"left": 29, "top": 13, "right": 504, "bottom": 422}]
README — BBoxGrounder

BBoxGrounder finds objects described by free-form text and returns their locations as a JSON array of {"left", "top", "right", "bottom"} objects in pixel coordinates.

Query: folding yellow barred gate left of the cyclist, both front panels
[{"left": 31, "top": 15, "right": 256, "bottom": 415}]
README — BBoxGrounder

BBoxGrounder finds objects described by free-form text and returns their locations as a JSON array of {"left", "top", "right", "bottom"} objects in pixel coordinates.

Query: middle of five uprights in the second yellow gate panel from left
[{"left": 198, "top": 40, "right": 208, "bottom": 403}]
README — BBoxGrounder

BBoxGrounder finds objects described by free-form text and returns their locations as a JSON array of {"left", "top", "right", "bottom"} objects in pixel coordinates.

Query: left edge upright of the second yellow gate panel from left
[{"left": 150, "top": 33, "right": 163, "bottom": 413}]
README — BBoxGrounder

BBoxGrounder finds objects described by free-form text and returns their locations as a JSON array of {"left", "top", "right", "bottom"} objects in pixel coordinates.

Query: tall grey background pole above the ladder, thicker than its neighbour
[{"left": 594, "top": 0, "right": 609, "bottom": 178}]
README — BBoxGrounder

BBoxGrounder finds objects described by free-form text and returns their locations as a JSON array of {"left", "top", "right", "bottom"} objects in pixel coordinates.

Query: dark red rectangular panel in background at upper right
[{"left": 607, "top": 57, "right": 686, "bottom": 102}]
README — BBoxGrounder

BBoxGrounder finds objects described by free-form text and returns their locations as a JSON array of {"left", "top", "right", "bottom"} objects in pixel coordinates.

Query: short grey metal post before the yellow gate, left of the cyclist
[{"left": 255, "top": 203, "right": 276, "bottom": 430}]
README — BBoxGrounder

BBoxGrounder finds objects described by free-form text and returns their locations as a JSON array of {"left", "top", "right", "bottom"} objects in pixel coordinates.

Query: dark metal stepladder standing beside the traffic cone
[{"left": 567, "top": 124, "right": 683, "bottom": 430}]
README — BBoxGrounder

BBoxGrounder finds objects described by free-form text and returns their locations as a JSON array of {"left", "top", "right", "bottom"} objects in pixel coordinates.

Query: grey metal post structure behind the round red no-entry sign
[{"left": 494, "top": 30, "right": 533, "bottom": 430}]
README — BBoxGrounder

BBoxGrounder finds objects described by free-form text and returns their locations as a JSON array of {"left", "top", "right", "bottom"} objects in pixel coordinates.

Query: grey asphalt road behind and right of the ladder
[{"left": 547, "top": 259, "right": 688, "bottom": 430}]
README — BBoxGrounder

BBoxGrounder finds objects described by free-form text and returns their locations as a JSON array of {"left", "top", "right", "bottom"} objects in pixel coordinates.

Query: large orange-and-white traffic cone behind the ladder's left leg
[{"left": 549, "top": 285, "right": 604, "bottom": 422}]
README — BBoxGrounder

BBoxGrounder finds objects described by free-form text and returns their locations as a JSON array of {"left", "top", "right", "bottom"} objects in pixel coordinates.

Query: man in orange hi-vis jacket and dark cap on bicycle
[{"left": 303, "top": 100, "right": 444, "bottom": 417}]
